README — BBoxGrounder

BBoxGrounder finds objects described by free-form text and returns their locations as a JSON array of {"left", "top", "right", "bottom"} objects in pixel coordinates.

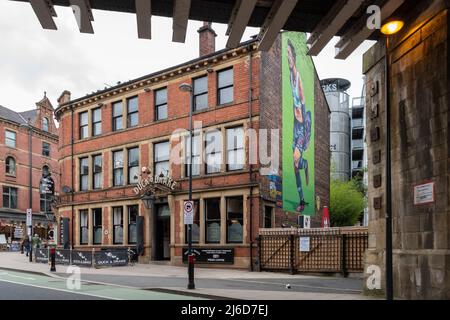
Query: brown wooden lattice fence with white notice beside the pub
[{"left": 258, "top": 228, "right": 368, "bottom": 276}]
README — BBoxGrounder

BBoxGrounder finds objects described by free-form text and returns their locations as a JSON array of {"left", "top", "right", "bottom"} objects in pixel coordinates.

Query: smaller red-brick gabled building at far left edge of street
[{"left": 0, "top": 97, "right": 59, "bottom": 236}]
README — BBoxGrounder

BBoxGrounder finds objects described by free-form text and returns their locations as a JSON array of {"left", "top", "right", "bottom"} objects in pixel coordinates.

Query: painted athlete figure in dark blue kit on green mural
[{"left": 287, "top": 40, "right": 312, "bottom": 212}]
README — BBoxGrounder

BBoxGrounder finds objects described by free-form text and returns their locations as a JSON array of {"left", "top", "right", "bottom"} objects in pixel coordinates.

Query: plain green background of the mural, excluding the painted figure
[{"left": 282, "top": 32, "right": 315, "bottom": 216}]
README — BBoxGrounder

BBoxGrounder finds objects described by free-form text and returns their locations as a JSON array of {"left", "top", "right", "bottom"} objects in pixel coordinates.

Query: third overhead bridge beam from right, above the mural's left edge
[{"left": 258, "top": 0, "right": 298, "bottom": 51}]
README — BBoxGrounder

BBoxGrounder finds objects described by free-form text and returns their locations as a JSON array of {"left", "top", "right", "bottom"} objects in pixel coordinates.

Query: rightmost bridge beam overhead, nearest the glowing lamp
[{"left": 335, "top": 0, "right": 405, "bottom": 60}]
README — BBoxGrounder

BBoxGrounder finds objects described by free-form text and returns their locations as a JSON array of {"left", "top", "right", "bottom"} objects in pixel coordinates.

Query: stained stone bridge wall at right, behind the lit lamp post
[{"left": 364, "top": 1, "right": 450, "bottom": 299}]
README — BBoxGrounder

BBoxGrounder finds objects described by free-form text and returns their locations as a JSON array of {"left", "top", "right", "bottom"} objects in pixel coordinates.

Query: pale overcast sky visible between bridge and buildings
[{"left": 0, "top": 0, "right": 372, "bottom": 111}]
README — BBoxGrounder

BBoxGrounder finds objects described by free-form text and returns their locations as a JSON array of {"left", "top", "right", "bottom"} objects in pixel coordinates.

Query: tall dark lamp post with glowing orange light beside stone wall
[{"left": 381, "top": 19, "right": 404, "bottom": 300}]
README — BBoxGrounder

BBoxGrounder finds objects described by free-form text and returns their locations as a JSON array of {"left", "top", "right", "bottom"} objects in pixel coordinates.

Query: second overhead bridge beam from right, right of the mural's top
[{"left": 308, "top": 0, "right": 363, "bottom": 56}]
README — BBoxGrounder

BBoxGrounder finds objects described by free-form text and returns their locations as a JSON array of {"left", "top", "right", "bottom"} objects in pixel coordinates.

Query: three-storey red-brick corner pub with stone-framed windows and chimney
[{"left": 55, "top": 23, "right": 329, "bottom": 268}]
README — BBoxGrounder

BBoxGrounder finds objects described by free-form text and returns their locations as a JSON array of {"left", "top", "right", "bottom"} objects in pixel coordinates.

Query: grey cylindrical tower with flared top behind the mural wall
[{"left": 321, "top": 78, "right": 351, "bottom": 181}]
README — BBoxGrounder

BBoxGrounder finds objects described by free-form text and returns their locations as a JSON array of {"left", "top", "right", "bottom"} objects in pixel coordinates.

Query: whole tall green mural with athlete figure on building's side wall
[{"left": 282, "top": 32, "right": 315, "bottom": 216}]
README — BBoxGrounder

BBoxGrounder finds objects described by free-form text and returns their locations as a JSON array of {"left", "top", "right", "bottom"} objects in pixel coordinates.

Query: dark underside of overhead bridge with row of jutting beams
[{"left": 12, "top": 0, "right": 411, "bottom": 59}]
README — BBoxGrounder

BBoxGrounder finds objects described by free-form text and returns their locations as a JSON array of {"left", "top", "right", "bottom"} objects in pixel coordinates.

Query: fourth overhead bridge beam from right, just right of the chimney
[{"left": 226, "top": 0, "right": 257, "bottom": 49}]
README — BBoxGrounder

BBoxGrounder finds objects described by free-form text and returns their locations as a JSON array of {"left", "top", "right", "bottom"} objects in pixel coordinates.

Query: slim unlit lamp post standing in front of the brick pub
[{"left": 180, "top": 83, "right": 195, "bottom": 290}]
